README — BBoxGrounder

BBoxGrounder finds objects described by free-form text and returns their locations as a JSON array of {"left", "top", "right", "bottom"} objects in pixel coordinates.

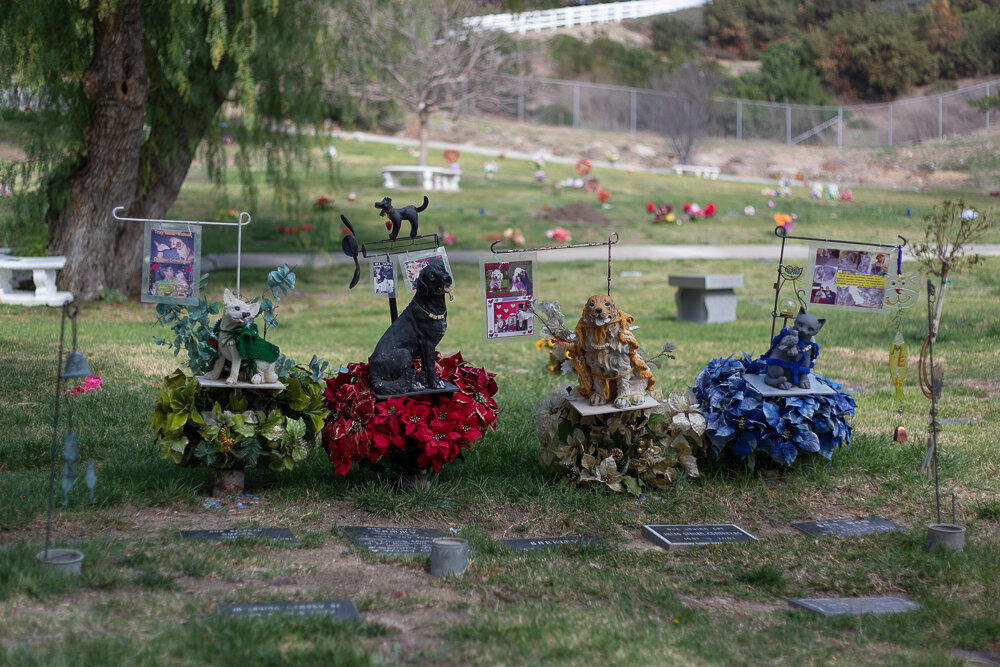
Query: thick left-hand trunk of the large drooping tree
[{"left": 49, "top": 0, "right": 147, "bottom": 299}]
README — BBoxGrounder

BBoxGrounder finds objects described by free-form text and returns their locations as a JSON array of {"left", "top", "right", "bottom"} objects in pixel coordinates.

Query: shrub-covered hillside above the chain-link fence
[{"left": 524, "top": 0, "right": 1000, "bottom": 104}]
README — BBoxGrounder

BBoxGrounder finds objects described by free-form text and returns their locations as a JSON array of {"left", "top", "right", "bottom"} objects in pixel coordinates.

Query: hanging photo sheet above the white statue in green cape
[{"left": 141, "top": 222, "right": 201, "bottom": 306}]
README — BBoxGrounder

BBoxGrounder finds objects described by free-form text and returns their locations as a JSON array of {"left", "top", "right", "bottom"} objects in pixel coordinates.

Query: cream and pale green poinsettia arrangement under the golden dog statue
[{"left": 535, "top": 387, "right": 707, "bottom": 496}]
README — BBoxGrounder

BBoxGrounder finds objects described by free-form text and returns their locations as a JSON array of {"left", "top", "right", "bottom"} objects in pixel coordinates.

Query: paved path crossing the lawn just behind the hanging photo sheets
[{"left": 201, "top": 242, "right": 1000, "bottom": 271}]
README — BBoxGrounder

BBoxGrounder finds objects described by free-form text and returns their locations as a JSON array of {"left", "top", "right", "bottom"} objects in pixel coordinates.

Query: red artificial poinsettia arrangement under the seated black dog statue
[{"left": 323, "top": 353, "right": 497, "bottom": 475}]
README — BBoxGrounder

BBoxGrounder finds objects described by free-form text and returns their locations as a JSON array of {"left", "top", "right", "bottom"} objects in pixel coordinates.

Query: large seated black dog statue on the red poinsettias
[{"left": 368, "top": 260, "right": 451, "bottom": 396}]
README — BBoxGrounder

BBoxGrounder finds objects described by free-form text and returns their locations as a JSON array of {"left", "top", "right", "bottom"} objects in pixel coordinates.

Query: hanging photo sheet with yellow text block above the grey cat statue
[{"left": 806, "top": 241, "right": 899, "bottom": 313}]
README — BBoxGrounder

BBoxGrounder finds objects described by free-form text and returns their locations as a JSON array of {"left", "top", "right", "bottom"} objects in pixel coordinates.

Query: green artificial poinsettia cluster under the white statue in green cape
[{"left": 151, "top": 369, "right": 329, "bottom": 470}]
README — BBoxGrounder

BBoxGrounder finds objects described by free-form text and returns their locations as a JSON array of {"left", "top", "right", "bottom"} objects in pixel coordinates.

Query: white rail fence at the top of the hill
[{"left": 466, "top": 0, "right": 707, "bottom": 34}]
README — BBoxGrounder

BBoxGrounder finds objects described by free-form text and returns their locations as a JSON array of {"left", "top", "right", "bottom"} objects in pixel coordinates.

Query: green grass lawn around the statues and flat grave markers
[{"left": 0, "top": 134, "right": 1000, "bottom": 665}]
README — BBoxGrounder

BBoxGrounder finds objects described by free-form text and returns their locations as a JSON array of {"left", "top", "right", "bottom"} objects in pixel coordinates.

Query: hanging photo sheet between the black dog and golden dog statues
[{"left": 479, "top": 253, "right": 537, "bottom": 343}]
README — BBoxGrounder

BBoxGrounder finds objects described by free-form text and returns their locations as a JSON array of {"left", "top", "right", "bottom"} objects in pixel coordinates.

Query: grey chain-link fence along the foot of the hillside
[{"left": 494, "top": 79, "right": 1000, "bottom": 147}]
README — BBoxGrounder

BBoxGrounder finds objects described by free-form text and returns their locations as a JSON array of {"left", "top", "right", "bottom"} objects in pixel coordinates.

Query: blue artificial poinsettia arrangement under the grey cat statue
[{"left": 694, "top": 354, "right": 854, "bottom": 465}]
